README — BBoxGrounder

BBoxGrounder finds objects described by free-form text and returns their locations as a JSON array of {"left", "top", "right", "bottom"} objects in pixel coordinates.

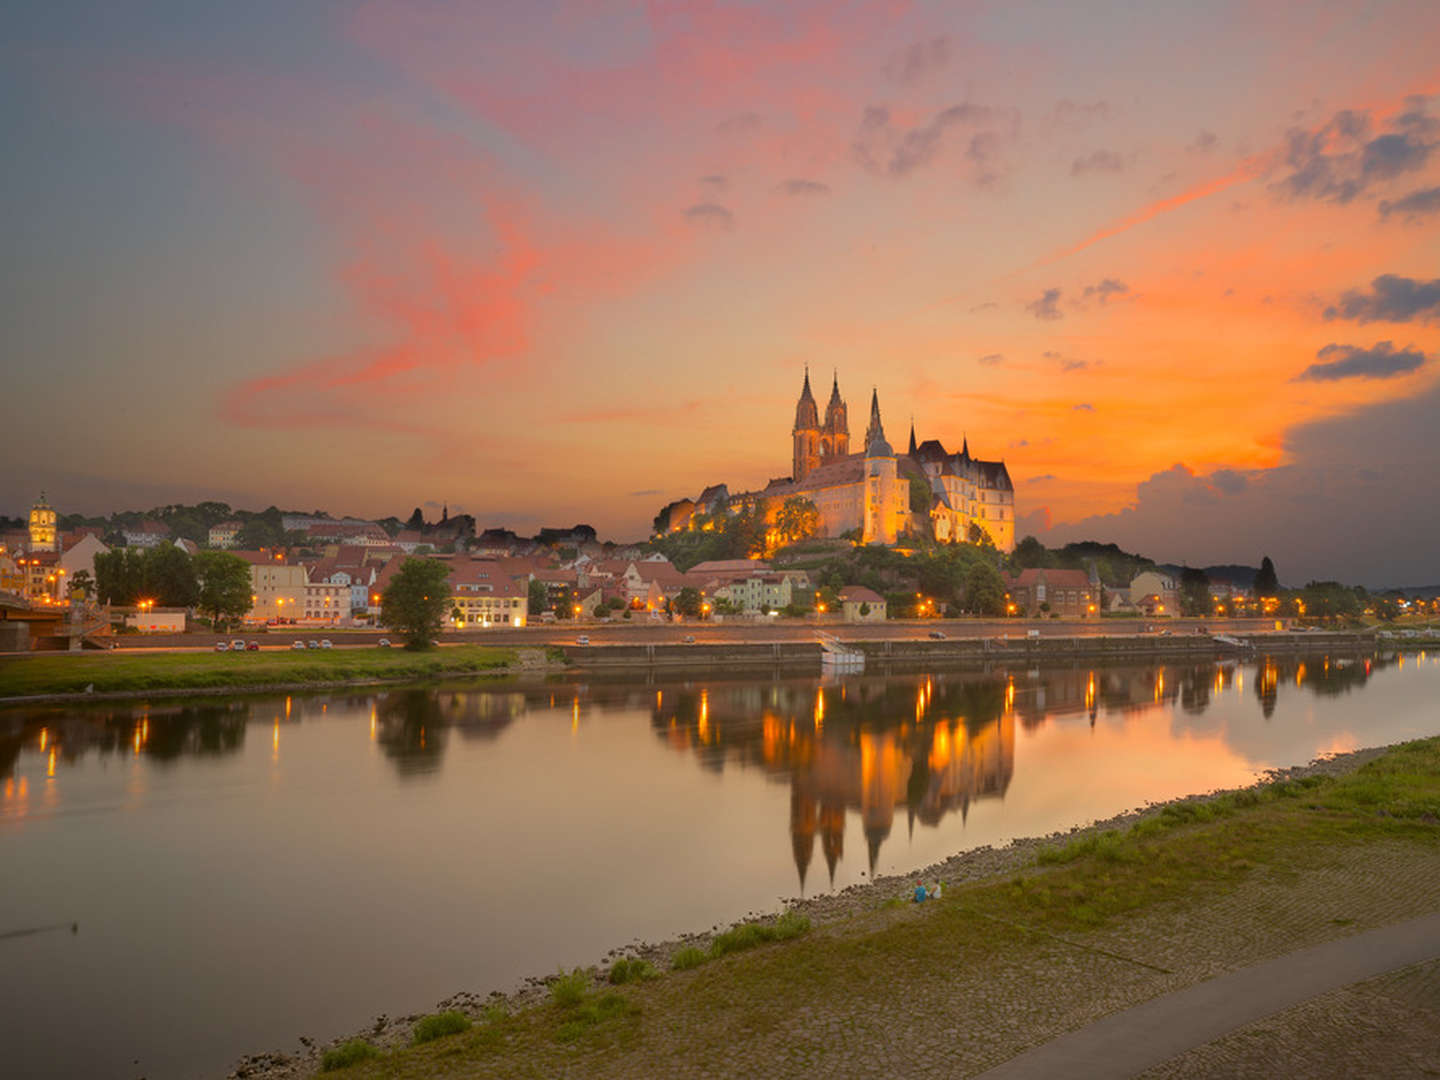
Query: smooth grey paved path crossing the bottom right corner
[{"left": 981, "top": 913, "right": 1440, "bottom": 1080}]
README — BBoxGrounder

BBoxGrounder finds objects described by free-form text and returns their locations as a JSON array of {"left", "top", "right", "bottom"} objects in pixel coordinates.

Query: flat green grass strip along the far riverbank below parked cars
[{"left": 0, "top": 645, "right": 516, "bottom": 697}]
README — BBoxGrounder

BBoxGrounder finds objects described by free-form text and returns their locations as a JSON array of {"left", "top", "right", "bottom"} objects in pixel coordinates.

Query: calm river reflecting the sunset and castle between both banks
[{"left": 8, "top": 655, "right": 1440, "bottom": 1080}]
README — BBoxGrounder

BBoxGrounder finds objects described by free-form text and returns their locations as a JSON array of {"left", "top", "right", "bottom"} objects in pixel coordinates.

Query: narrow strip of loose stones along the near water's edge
[{"left": 228, "top": 746, "right": 1391, "bottom": 1080}]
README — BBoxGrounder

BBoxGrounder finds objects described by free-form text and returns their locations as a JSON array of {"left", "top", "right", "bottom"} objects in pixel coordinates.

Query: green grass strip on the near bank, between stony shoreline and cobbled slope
[{"left": 318, "top": 739, "right": 1440, "bottom": 1077}]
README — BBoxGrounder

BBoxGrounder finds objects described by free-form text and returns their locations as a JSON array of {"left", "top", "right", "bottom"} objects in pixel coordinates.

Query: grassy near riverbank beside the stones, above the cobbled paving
[{"left": 309, "top": 739, "right": 1440, "bottom": 1080}]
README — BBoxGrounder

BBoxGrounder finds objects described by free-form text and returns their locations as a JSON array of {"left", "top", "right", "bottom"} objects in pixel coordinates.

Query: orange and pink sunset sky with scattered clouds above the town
[{"left": 0, "top": 0, "right": 1440, "bottom": 585}]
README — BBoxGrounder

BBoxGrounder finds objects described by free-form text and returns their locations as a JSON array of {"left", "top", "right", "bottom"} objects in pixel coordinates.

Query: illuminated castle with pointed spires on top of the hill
[{"left": 655, "top": 370, "right": 1015, "bottom": 552}]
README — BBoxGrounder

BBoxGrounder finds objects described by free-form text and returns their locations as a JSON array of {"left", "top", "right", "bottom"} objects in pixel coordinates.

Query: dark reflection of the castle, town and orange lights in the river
[{"left": 0, "top": 652, "right": 1416, "bottom": 869}]
